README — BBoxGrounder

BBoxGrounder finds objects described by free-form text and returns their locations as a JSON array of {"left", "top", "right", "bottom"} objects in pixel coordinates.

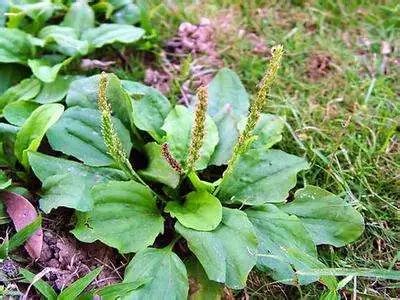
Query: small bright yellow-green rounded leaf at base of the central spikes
[{"left": 165, "top": 191, "right": 222, "bottom": 231}]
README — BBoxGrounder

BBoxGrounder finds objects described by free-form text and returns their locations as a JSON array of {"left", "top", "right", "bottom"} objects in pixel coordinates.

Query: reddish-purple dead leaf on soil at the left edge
[{"left": 1, "top": 191, "right": 43, "bottom": 259}]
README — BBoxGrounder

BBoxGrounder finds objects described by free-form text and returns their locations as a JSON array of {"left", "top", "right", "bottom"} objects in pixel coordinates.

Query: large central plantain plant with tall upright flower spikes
[{"left": 2, "top": 46, "right": 364, "bottom": 299}]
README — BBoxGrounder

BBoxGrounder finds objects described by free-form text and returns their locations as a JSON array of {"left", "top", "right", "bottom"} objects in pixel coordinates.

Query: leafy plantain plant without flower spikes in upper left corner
[{"left": 0, "top": 0, "right": 148, "bottom": 115}]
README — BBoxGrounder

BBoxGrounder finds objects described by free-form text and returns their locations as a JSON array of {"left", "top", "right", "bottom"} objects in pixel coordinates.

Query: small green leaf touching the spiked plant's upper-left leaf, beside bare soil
[{"left": 32, "top": 75, "right": 76, "bottom": 104}]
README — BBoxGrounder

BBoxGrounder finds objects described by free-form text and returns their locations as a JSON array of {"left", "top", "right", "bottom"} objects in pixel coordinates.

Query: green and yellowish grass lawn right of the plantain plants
[{"left": 122, "top": 0, "right": 400, "bottom": 298}]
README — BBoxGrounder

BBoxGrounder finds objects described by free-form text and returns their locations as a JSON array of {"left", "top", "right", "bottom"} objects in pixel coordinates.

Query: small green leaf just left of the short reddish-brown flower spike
[{"left": 138, "top": 143, "right": 180, "bottom": 189}]
